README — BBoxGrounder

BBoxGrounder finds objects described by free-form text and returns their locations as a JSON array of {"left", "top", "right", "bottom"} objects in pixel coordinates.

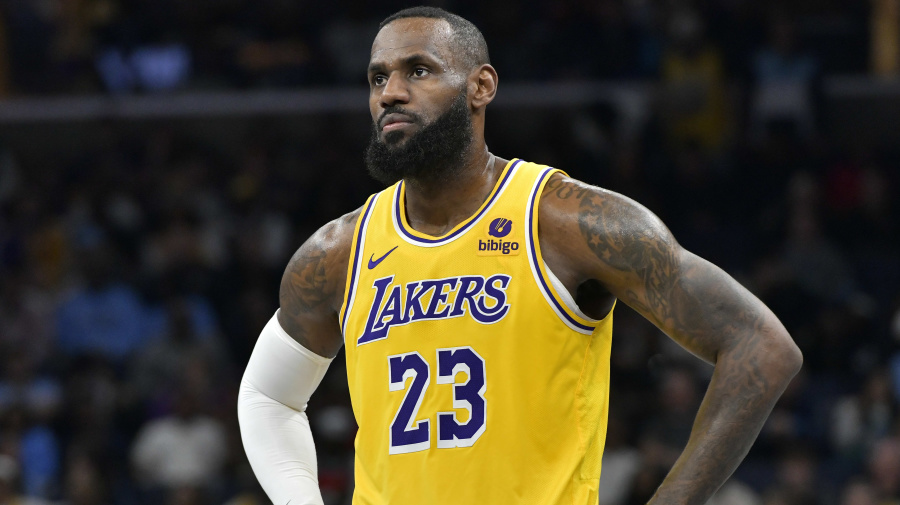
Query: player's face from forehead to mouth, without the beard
[{"left": 368, "top": 18, "right": 466, "bottom": 147}]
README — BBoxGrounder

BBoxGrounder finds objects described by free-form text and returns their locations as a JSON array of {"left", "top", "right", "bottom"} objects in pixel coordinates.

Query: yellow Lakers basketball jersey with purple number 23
[{"left": 340, "top": 160, "right": 612, "bottom": 505}]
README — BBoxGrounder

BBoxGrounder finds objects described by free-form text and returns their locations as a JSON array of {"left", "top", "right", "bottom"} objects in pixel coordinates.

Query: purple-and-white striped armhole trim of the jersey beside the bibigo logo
[{"left": 525, "top": 167, "right": 612, "bottom": 335}]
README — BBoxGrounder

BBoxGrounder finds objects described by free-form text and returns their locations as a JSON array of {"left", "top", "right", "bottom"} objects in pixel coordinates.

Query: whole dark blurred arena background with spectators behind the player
[{"left": 0, "top": 0, "right": 900, "bottom": 505}]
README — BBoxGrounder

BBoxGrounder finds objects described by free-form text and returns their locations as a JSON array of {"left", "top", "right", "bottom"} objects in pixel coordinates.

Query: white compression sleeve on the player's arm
[{"left": 238, "top": 313, "right": 331, "bottom": 505}]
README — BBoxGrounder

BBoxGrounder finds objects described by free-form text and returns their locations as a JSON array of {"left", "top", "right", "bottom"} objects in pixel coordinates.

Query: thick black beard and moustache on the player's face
[{"left": 366, "top": 90, "right": 474, "bottom": 186}]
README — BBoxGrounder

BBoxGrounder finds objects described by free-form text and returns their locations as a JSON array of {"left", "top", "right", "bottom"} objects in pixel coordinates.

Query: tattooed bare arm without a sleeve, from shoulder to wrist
[{"left": 539, "top": 174, "right": 802, "bottom": 504}]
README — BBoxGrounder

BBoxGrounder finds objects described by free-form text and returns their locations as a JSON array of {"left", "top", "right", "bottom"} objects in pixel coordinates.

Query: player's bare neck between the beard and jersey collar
[{"left": 403, "top": 146, "right": 507, "bottom": 236}]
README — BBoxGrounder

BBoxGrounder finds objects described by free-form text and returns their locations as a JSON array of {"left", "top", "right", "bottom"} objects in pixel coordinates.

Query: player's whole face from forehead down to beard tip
[{"left": 366, "top": 18, "right": 474, "bottom": 184}]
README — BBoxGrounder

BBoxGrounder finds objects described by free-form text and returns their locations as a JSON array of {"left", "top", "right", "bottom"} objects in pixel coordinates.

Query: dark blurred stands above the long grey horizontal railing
[{"left": 0, "top": 0, "right": 880, "bottom": 95}]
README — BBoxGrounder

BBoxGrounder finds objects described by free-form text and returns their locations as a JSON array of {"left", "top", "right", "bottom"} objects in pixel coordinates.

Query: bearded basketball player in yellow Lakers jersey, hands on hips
[{"left": 238, "top": 4, "right": 802, "bottom": 505}]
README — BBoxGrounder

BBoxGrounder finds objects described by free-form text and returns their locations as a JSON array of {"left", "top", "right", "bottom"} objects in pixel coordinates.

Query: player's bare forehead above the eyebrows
[{"left": 369, "top": 18, "right": 453, "bottom": 63}]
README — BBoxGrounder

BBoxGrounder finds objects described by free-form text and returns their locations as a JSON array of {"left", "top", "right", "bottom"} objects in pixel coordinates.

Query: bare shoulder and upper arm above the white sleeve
[{"left": 278, "top": 204, "right": 362, "bottom": 356}]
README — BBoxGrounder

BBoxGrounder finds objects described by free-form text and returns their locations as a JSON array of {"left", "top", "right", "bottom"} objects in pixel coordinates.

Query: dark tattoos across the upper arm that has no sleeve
[{"left": 578, "top": 192, "right": 765, "bottom": 361}]
